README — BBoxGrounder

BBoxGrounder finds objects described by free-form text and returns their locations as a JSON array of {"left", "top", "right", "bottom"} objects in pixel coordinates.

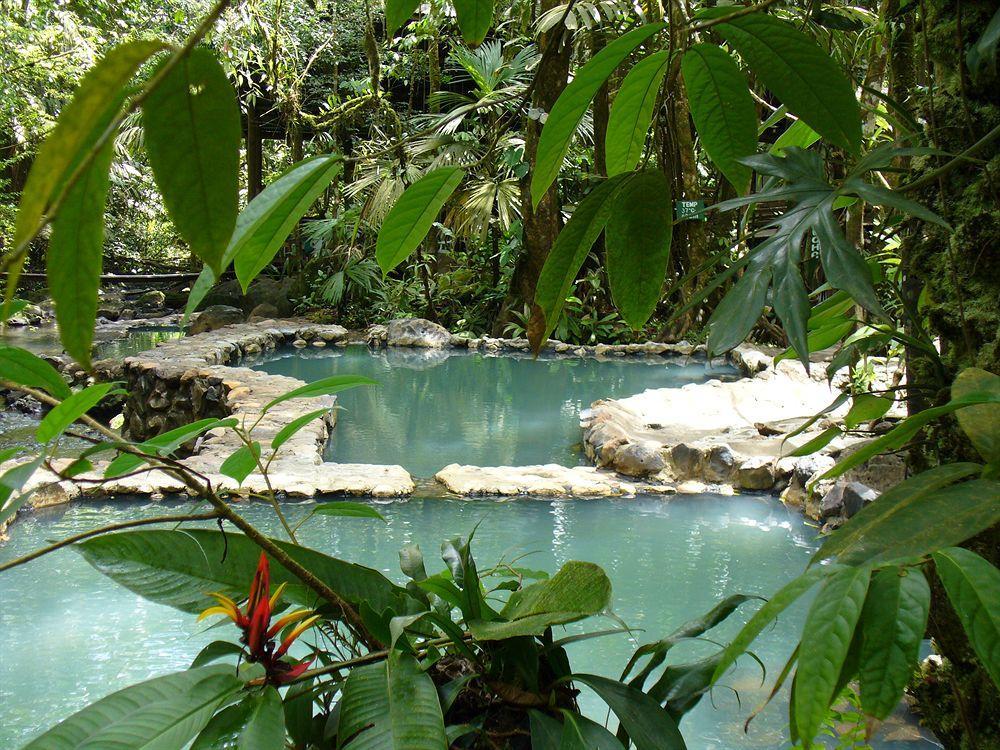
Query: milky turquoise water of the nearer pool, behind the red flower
[{"left": 0, "top": 495, "right": 934, "bottom": 750}]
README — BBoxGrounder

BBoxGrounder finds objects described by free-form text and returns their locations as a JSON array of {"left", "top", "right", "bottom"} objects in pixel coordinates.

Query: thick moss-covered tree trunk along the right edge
[{"left": 890, "top": 0, "right": 1000, "bottom": 750}]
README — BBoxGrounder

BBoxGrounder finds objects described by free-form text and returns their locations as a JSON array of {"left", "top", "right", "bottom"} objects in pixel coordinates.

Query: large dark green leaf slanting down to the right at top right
[{"left": 714, "top": 13, "right": 861, "bottom": 154}]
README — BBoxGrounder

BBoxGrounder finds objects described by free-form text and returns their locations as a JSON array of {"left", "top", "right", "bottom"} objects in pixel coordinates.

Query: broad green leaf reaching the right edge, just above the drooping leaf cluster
[{"left": 813, "top": 464, "right": 1000, "bottom": 565}]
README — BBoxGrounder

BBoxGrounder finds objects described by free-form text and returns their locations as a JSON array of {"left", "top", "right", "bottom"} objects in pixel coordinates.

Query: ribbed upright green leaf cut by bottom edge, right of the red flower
[{"left": 337, "top": 651, "right": 448, "bottom": 750}]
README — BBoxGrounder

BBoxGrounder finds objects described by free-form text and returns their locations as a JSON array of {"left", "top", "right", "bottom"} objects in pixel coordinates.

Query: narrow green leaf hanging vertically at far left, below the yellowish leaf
[{"left": 45, "top": 139, "right": 114, "bottom": 369}]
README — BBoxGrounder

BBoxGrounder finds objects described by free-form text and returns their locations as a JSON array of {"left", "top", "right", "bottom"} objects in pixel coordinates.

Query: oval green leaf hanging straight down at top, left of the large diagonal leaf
[{"left": 681, "top": 43, "right": 757, "bottom": 195}]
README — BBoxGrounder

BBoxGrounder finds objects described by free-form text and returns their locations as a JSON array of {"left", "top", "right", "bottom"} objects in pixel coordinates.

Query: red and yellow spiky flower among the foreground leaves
[{"left": 198, "top": 552, "right": 319, "bottom": 685}]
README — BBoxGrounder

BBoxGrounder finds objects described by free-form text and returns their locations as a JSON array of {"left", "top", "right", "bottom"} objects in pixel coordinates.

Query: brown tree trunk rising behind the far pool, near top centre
[{"left": 493, "top": 0, "right": 572, "bottom": 335}]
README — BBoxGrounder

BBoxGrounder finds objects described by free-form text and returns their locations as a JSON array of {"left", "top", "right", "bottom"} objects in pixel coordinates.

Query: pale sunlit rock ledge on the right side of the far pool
[{"left": 580, "top": 346, "right": 904, "bottom": 520}]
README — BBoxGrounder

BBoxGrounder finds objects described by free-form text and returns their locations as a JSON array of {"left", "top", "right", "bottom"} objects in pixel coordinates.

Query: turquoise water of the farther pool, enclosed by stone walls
[{"left": 256, "top": 346, "right": 737, "bottom": 477}]
